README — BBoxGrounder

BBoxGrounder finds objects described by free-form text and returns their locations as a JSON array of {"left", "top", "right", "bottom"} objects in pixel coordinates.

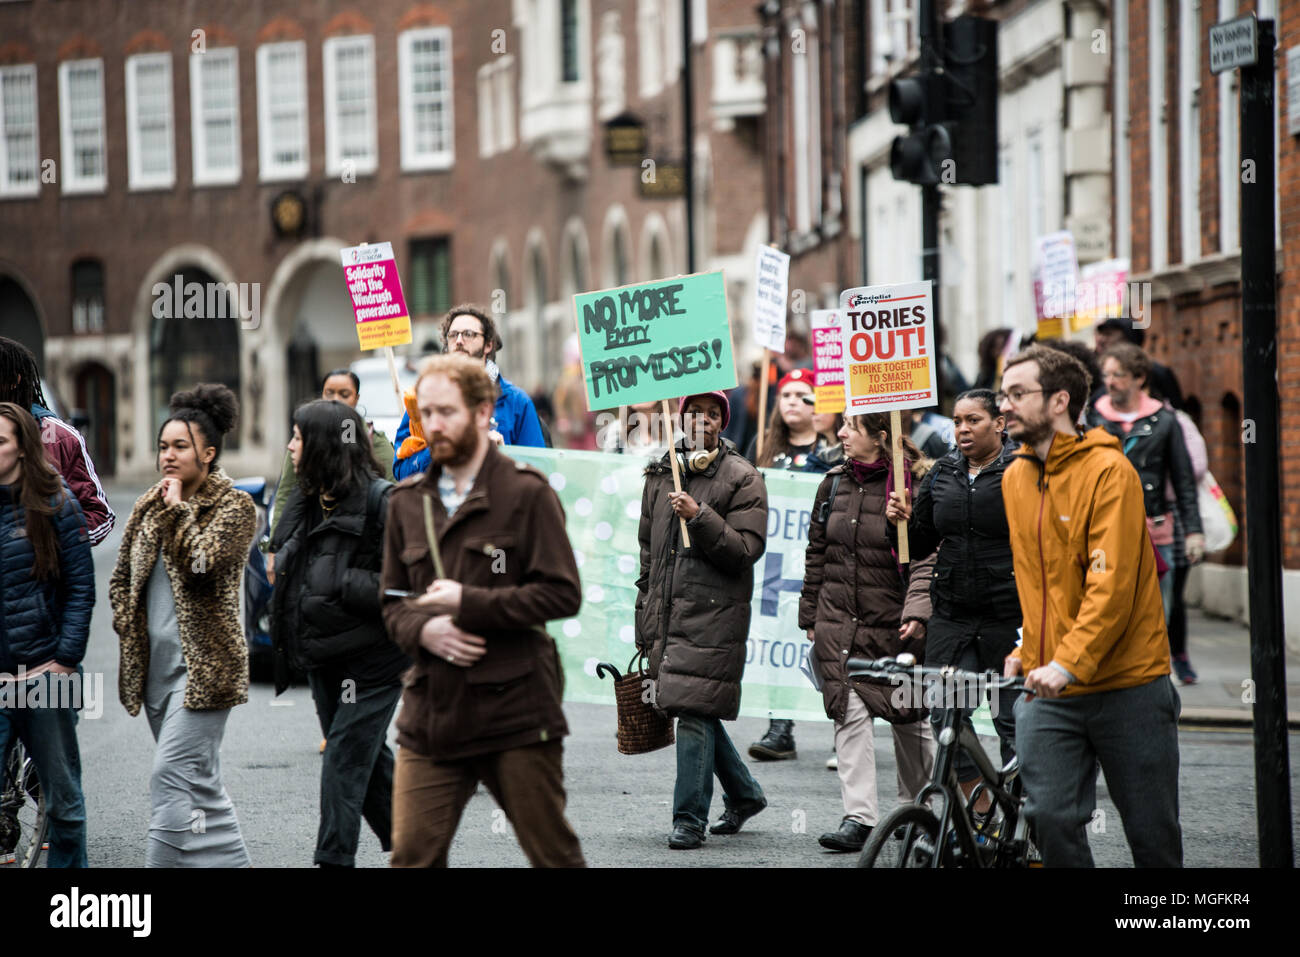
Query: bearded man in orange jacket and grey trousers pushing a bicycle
[{"left": 998, "top": 346, "right": 1183, "bottom": 867}]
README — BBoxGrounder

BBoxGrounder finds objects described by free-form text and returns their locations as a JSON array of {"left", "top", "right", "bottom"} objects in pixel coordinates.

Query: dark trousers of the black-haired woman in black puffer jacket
[{"left": 307, "top": 666, "right": 402, "bottom": 867}]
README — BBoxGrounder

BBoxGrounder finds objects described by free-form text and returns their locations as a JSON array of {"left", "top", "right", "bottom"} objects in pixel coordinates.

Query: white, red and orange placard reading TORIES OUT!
[{"left": 840, "top": 280, "right": 939, "bottom": 415}]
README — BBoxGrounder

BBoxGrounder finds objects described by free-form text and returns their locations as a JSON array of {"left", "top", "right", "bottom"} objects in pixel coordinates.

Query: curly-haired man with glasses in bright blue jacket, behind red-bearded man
[{"left": 393, "top": 306, "right": 550, "bottom": 481}]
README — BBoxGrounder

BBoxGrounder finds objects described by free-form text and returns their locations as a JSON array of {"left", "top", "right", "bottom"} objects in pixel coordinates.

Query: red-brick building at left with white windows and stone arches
[{"left": 0, "top": 0, "right": 766, "bottom": 477}]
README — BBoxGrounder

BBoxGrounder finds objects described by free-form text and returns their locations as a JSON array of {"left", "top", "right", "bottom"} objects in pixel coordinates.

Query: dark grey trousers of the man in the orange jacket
[{"left": 1015, "top": 675, "right": 1183, "bottom": 867}]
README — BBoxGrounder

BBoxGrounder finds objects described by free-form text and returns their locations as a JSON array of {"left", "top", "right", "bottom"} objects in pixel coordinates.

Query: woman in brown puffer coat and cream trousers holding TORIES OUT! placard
[{"left": 800, "top": 412, "right": 935, "bottom": 850}]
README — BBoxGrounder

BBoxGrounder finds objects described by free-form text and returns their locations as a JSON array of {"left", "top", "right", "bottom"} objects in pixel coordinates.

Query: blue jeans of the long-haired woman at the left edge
[{"left": 0, "top": 667, "right": 88, "bottom": 867}]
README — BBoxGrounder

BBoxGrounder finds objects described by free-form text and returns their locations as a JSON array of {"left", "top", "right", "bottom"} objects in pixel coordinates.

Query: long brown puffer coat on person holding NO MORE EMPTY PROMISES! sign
[{"left": 636, "top": 442, "right": 767, "bottom": 720}]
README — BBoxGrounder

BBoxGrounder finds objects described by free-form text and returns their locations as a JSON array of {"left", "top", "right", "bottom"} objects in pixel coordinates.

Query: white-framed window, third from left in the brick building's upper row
[{"left": 126, "top": 53, "right": 176, "bottom": 190}]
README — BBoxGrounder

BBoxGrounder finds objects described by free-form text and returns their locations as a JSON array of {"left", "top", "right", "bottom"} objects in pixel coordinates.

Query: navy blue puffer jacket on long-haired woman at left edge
[{"left": 0, "top": 484, "right": 95, "bottom": 675}]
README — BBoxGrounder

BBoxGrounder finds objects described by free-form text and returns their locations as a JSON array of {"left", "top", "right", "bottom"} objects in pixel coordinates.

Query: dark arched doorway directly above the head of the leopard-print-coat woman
[{"left": 150, "top": 267, "right": 243, "bottom": 451}]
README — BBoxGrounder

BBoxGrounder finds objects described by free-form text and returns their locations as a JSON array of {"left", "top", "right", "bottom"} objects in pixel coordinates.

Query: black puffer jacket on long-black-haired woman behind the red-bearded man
[{"left": 270, "top": 479, "right": 411, "bottom": 694}]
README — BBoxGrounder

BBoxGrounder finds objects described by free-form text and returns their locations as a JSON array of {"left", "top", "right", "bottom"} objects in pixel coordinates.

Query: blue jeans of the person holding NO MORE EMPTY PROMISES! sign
[{"left": 672, "top": 714, "right": 763, "bottom": 833}]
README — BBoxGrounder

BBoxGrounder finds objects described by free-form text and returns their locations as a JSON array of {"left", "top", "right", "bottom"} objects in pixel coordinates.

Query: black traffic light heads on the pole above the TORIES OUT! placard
[{"left": 889, "top": 17, "right": 997, "bottom": 186}]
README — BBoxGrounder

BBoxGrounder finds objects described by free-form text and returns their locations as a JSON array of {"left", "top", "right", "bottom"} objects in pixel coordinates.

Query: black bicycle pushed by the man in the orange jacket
[{"left": 848, "top": 654, "right": 1041, "bottom": 867}]
